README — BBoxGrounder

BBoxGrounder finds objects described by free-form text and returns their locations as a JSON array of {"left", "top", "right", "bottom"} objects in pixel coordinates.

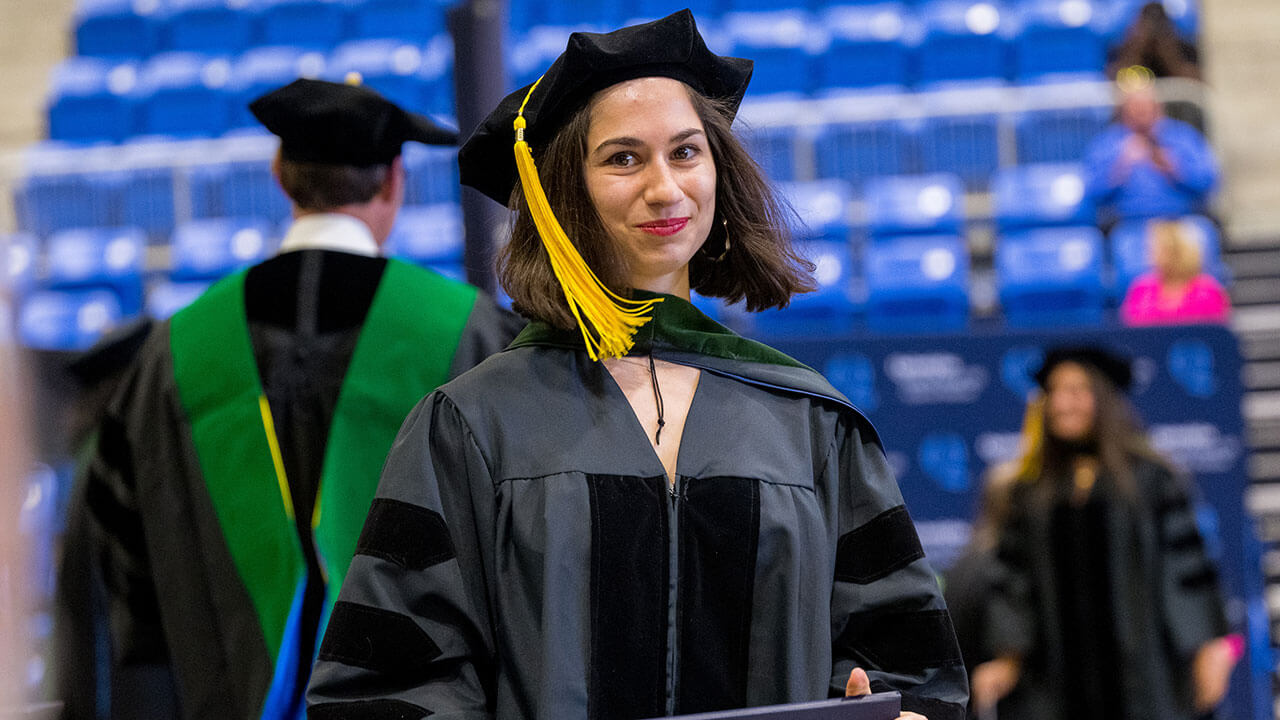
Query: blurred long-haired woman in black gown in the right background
[{"left": 973, "top": 347, "right": 1239, "bottom": 720}]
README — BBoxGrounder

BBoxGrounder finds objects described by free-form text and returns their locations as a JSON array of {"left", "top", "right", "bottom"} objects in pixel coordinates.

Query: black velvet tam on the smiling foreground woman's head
[{"left": 458, "top": 10, "right": 751, "bottom": 205}]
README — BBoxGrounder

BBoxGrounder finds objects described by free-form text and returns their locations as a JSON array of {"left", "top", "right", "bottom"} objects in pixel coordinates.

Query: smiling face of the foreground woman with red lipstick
[{"left": 584, "top": 77, "right": 716, "bottom": 299}]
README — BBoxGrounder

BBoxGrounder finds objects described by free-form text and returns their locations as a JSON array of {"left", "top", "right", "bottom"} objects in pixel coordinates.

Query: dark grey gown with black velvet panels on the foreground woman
[{"left": 307, "top": 296, "right": 968, "bottom": 720}]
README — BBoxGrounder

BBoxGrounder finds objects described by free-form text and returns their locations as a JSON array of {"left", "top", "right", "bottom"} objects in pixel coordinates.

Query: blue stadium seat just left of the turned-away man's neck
[{"left": 169, "top": 218, "right": 274, "bottom": 282}]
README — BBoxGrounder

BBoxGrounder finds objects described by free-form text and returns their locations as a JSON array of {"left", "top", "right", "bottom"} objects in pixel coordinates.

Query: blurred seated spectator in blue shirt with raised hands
[{"left": 1085, "top": 83, "right": 1219, "bottom": 229}]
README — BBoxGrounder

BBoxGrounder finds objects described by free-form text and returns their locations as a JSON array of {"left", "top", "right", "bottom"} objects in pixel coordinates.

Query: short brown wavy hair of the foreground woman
[{"left": 498, "top": 86, "right": 814, "bottom": 329}]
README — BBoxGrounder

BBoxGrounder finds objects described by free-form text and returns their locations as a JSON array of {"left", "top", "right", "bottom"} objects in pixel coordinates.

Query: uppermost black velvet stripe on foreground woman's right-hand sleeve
[{"left": 836, "top": 505, "right": 924, "bottom": 585}]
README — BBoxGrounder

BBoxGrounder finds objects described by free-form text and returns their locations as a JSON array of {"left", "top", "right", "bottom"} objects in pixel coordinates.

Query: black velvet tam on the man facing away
[{"left": 248, "top": 78, "right": 458, "bottom": 167}]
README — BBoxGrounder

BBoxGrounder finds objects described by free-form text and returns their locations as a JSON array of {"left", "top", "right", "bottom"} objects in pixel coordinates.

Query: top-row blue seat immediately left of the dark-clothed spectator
[{"left": 1012, "top": 0, "right": 1106, "bottom": 81}]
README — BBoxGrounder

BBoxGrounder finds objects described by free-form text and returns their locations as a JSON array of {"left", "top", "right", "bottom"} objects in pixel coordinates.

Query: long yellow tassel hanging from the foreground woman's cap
[{"left": 515, "top": 78, "right": 662, "bottom": 360}]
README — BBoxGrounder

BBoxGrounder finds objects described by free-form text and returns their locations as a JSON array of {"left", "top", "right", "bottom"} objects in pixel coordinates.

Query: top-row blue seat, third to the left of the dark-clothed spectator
[{"left": 814, "top": 3, "right": 911, "bottom": 90}]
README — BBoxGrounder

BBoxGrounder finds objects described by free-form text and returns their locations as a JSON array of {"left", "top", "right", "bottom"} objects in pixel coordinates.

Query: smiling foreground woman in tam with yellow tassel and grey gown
[{"left": 308, "top": 10, "right": 966, "bottom": 720}]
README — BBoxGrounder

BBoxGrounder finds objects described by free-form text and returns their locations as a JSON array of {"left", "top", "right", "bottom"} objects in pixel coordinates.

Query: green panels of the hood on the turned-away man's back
[{"left": 169, "top": 260, "right": 476, "bottom": 665}]
